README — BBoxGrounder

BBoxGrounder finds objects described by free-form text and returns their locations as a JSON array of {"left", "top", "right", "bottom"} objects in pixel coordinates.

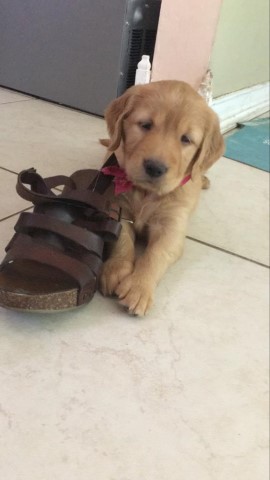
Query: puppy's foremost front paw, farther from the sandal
[{"left": 115, "top": 273, "right": 154, "bottom": 317}]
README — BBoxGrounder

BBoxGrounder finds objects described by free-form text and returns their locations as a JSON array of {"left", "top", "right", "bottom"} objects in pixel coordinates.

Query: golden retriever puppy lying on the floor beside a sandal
[{"left": 101, "top": 81, "right": 224, "bottom": 316}]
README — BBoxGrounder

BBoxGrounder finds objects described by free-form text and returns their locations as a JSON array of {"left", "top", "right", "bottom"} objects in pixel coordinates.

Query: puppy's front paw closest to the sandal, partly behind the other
[{"left": 100, "top": 258, "right": 134, "bottom": 295}]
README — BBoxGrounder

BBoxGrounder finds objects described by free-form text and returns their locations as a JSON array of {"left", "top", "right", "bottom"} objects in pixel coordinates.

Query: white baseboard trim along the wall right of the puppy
[{"left": 212, "top": 82, "right": 270, "bottom": 133}]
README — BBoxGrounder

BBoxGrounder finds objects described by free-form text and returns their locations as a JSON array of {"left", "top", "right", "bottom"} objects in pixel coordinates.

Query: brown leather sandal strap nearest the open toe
[{"left": 0, "top": 234, "right": 102, "bottom": 305}]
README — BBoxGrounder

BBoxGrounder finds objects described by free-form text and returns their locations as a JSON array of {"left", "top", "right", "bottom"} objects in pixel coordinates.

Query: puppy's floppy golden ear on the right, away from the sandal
[{"left": 191, "top": 111, "right": 224, "bottom": 178}]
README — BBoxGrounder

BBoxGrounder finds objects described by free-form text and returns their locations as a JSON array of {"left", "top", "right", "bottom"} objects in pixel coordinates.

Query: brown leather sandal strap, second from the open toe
[{"left": 14, "top": 212, "right": 104, "bottom": 257}]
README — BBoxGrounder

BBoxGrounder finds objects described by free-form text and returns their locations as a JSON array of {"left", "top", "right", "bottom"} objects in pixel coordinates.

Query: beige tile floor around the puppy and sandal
[{"left": 0, "top": 89, "right": 269, "bottom": 480}]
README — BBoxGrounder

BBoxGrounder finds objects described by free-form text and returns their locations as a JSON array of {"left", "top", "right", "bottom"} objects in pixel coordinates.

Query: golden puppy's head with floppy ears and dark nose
[{"left": 105, "top": 81, "right": 224, "bottom": 195}]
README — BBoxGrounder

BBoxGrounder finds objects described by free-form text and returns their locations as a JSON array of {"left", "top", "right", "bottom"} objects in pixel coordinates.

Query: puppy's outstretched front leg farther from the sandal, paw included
[{"left": 116, "top": 217, "right": 187, "bottom": 316}]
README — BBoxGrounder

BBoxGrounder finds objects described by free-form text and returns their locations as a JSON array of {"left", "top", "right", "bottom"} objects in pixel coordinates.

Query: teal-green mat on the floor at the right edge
[{"left": 225, "top": 118, "right": 270, "bottom": 172}]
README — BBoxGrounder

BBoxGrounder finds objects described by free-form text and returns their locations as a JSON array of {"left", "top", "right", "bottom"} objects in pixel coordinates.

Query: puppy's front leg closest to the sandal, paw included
[{"left": 100, "top": 222, "right": 135, "bottom": 295}]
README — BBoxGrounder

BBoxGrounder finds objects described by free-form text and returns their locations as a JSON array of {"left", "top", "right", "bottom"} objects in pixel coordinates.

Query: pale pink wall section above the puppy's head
[{"left": 152, "top": 0, "right": 222, "bottom": 88}]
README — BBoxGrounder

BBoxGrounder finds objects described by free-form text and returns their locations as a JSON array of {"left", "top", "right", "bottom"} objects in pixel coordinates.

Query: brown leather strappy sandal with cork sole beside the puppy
[{"left": 0, "top": 156, "right": 121, "bottom": 312}]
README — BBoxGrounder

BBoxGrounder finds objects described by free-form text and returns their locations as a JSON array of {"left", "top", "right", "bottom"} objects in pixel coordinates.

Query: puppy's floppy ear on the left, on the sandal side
[{"left": 105, "top": 89, "right": 133, "bottom": 151}]
